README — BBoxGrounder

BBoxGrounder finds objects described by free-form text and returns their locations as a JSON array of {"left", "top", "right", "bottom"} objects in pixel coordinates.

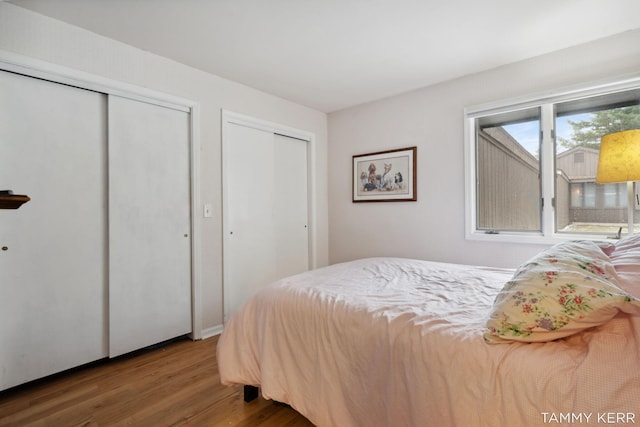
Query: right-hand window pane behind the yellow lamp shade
[{"left": 555, "top": 98, "right": 640, "bottom": 234}]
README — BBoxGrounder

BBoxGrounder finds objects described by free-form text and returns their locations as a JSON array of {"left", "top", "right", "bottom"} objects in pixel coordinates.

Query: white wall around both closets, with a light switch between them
[{"left": 0, "top": 2, "right": 328, "bottom": 338}]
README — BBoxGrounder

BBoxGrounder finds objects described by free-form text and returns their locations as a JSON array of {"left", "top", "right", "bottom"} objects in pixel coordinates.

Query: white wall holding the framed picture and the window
[{"left": 328, "top": 31, "right": 640, "bottom": 267}]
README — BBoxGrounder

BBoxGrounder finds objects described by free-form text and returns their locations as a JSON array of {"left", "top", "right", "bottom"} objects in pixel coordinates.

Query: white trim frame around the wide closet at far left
[{"left": 0, "top": 49, "right": 203, "bottom": 339}]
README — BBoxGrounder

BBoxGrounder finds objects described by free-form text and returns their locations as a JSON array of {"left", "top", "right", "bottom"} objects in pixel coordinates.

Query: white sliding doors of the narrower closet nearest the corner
[{"left": 223, "top": 124, "right": 309, "bottom": 321}]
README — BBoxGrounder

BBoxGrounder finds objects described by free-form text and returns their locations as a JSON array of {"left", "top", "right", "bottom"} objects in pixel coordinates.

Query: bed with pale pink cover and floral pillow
[{"left": 217, "top": 236, "right": 640, "bottom": 427}]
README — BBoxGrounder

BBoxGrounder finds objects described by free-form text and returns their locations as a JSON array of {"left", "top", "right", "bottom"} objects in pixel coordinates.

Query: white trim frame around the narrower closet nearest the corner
[{"left": 221, "top": 109, "right": 317, "bottom": 323}]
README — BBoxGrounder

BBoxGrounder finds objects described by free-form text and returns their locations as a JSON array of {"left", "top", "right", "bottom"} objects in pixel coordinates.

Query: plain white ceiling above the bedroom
[{"left": 8, "top": 0, "right": 640, "bottom": 112}]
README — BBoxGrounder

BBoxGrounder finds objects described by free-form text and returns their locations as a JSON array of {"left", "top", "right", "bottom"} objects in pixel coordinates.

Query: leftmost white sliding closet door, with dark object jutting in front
[{"left": 0, "top": 71, "right": 107, "bottom": 389}]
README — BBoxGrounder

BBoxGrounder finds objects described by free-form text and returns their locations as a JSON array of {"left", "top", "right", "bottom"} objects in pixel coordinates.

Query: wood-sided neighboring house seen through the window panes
[{"left": 477, "top": 127, "right": 627, "bottom": 230}]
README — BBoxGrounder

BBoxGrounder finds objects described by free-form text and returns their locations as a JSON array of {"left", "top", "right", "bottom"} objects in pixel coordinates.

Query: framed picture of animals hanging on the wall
[{"left": 352, "top": 147, "right": 418, "bottom": 203}]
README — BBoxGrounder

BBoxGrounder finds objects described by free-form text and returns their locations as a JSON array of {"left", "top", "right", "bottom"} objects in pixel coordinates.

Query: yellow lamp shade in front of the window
[{"left": 596, "top": 129, "right": 640, "bottom": 184}]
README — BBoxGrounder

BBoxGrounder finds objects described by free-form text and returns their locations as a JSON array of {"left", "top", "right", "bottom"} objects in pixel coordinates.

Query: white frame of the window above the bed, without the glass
[{"left": 464, "top": 74, "right": 640, "bottom": 244}]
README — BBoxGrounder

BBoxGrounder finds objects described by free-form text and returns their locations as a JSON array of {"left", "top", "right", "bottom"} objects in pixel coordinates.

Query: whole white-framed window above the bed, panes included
[{"left": 465, "top": 78, "right": 640, "bottom": 240}]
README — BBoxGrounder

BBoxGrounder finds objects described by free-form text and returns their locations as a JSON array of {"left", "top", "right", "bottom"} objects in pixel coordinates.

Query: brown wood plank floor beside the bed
[{"left": 0, "top": 337, "right": 312, "bottom": 427}]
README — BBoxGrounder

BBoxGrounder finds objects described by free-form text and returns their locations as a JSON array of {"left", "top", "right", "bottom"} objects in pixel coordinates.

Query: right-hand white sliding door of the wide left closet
[{"left": 109, "top": 96, "right": 191, "bottom": 356}]
